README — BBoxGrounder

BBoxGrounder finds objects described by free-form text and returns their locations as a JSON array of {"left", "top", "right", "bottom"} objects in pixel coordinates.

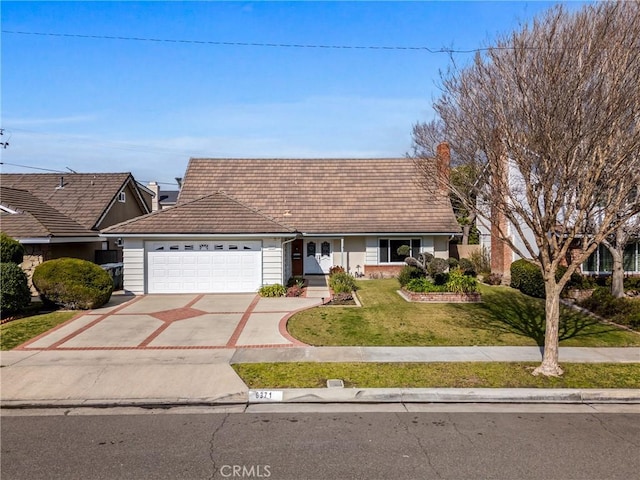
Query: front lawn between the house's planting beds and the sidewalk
[{"left": 287, "top": 279, "right": 640, "bottom": 347}]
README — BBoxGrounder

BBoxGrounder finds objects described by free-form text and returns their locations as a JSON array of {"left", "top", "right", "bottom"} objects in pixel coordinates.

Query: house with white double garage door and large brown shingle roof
[{"left": 102, "top": 158, "right": 460, "bottom": 294}]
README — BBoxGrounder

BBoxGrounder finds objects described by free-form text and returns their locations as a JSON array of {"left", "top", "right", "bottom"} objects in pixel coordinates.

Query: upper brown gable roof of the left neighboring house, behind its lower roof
[{"left": 0, "top": 173, "right": 132, "bottom": 229}]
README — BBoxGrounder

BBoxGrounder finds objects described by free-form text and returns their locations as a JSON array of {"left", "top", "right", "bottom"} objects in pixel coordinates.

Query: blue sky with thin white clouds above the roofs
[{"left": 0, "top": 1, "right": 579, "bottom": 189}]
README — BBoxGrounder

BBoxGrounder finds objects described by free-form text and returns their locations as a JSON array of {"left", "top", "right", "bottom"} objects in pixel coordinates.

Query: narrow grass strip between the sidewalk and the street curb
[{"left": 233, "top": 362, "right": 640, "bottom": 388}]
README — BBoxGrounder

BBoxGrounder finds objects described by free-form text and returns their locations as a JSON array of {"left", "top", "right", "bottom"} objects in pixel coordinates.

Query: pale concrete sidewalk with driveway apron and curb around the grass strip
[{"left": 0, "top": 347, "right": 640, "bottom": 408}]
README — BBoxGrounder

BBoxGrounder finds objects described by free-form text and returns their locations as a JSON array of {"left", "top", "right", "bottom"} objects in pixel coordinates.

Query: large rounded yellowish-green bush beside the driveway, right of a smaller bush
[{"left": 33, "top": 258, "right": 113, "bottom": 310}]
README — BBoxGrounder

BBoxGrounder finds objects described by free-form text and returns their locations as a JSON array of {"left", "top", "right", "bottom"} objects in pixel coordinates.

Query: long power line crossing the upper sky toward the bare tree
[{"left": 2, "top": 30, "right": 490, "bottom": 54}]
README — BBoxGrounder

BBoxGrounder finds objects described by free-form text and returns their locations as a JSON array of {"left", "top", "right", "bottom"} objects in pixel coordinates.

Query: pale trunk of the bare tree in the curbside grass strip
[{"left": 533, "top": 275, "right": 564, "bottom": 377}]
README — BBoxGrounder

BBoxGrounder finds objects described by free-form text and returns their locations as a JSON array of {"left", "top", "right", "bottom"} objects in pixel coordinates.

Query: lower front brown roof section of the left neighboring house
[{"left": 0, "top": 186, "right": 97, "bottom": 238}]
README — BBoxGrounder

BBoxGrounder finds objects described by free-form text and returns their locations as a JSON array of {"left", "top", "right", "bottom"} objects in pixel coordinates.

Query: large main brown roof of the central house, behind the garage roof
[{"left": 176, "top": 158, "right": 459, "bottom": 234}]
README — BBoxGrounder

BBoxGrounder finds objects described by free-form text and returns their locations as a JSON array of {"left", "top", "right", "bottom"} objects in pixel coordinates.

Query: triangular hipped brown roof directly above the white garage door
[{"left": 103, "top": 192, "right": 294, "bottom": 235}]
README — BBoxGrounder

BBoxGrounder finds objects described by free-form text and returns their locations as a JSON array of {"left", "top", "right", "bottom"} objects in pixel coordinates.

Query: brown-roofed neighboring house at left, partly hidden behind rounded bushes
[{"left": 0, "top": 173, "right": 152, "bottom": 284}]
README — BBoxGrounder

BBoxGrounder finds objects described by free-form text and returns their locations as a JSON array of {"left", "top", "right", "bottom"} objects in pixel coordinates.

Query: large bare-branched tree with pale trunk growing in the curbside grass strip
[{"left": 424, "top": 2, "right": 640, "bottom": 376}]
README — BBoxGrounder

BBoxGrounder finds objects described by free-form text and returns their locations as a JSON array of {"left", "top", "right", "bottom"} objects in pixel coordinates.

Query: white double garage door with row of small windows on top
[{"left": 147, "top": 241, "right": 262, "bottom": 293}]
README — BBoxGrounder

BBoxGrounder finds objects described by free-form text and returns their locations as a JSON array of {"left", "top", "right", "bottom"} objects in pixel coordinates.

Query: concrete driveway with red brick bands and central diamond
[{"left": 17, "top": 294, "right": 321, "bottom": 351}]
